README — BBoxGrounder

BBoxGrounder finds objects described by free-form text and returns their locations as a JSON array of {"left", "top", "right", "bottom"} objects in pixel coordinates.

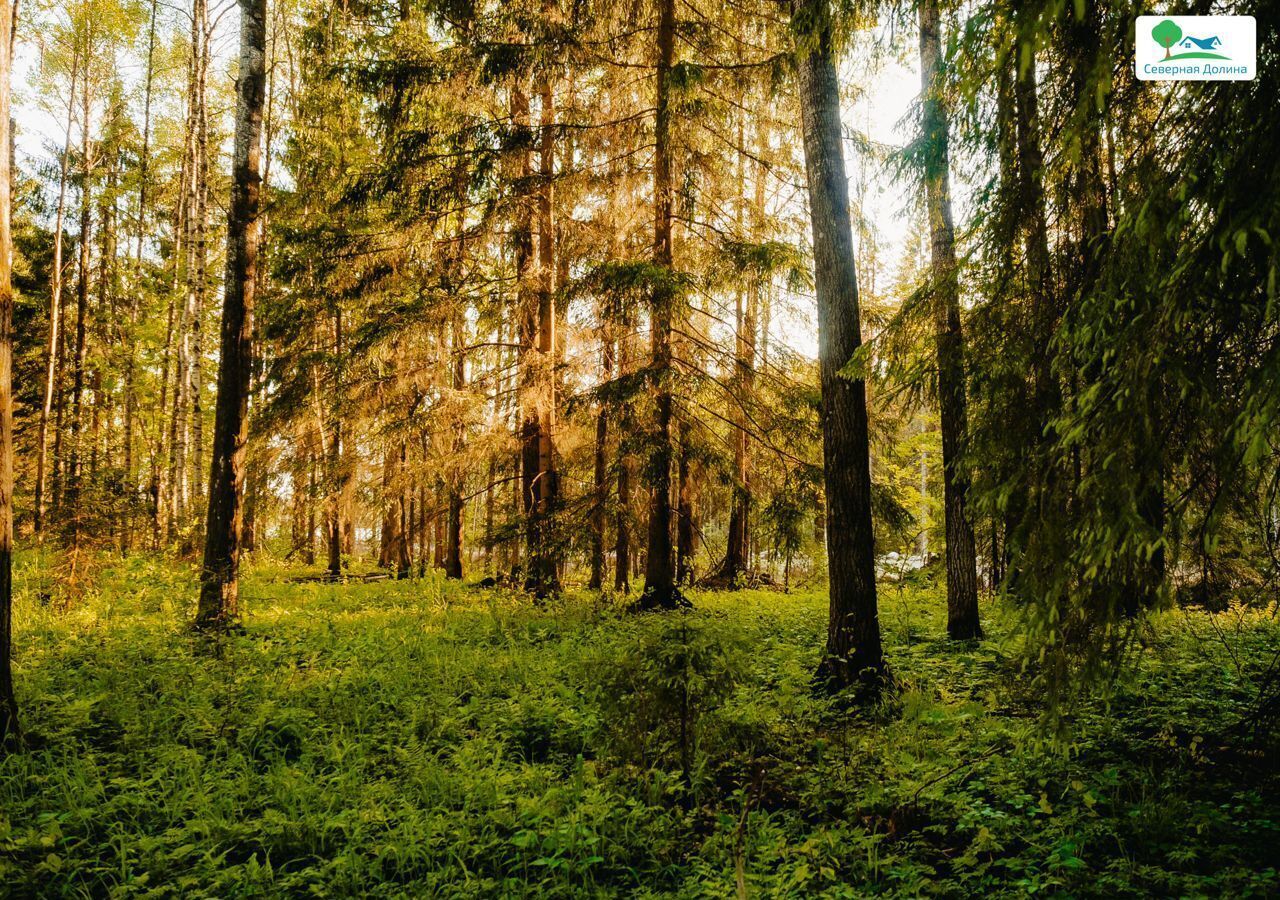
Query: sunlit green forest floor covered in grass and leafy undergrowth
[{"left": 0, "top": 554, "right": 1280, "bottom": 897}]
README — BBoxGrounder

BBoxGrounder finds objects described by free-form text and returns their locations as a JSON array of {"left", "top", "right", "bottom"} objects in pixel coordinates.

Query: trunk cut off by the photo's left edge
[{"left": 0, "top": 0, "right": 22, "bottom": 748}]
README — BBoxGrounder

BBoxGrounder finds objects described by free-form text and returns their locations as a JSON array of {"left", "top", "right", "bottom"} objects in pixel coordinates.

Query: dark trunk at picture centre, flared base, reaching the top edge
[{"left": 639, "top": 0, "right": 682, "bottom": 609}]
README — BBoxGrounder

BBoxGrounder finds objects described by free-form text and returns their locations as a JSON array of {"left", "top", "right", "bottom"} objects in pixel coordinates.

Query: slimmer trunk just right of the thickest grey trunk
[{"left": 920, "top": 0, "right": 982, "bottom": 640}]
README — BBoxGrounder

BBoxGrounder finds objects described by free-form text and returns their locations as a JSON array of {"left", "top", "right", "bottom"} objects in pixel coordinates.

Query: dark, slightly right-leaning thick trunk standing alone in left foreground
[{"left": 196, "top": 0, "right": 266, "bottom": 627}]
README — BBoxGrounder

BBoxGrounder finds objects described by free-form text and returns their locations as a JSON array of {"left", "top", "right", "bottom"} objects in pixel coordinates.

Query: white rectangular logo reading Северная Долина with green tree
[{"left": 1134, "top": 15, "right": 1258, "bottom": 81}]
